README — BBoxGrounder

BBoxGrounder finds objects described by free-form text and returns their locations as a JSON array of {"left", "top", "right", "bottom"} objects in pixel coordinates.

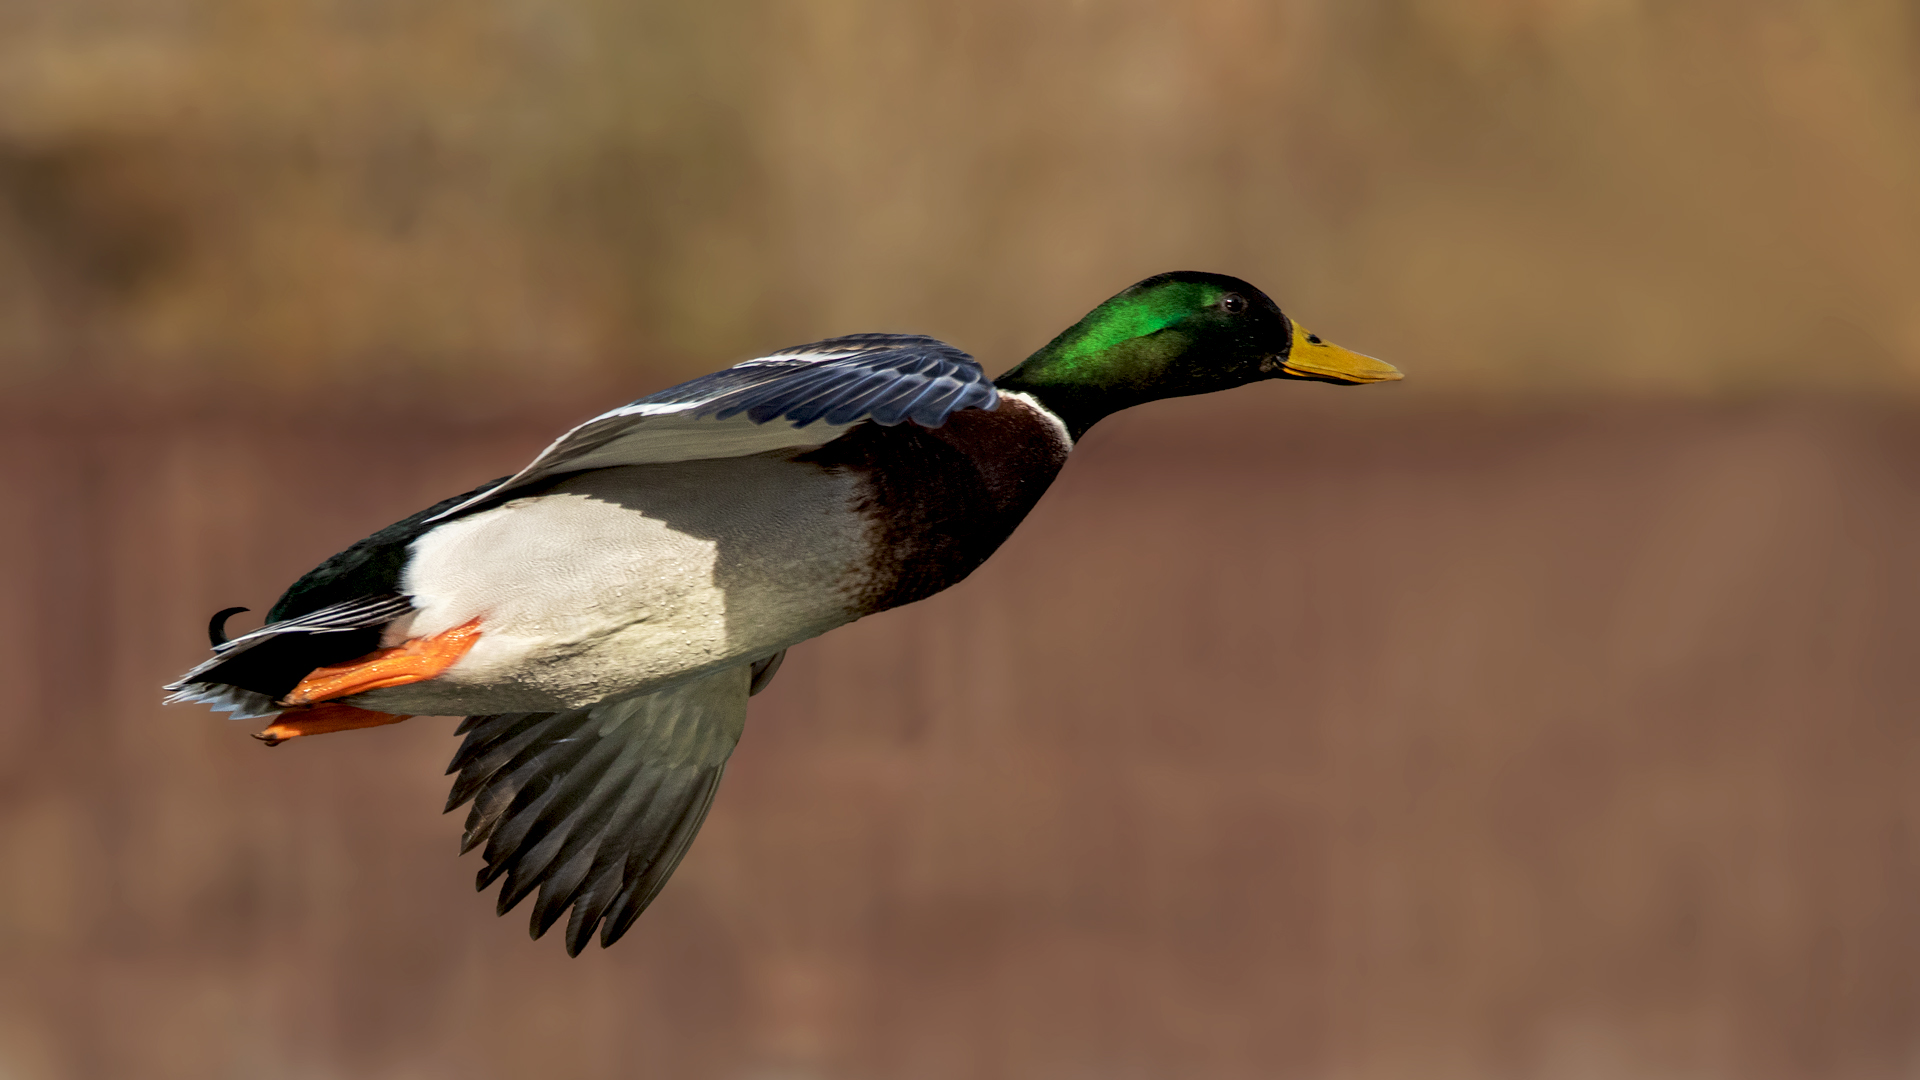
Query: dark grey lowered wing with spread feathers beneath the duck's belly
[{"left": 447, "top": 665, "right": 755, "bottom": 955}]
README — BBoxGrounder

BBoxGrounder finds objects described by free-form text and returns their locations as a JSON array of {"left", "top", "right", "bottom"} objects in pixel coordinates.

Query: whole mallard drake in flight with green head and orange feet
[{"left": 167, "top": 273, "right": 1400, "bottom": 955}]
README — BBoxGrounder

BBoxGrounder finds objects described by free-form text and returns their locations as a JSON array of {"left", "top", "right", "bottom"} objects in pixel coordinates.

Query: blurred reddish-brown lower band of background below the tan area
[{"left": 0, "top": 386, "right": 1920, "bottom": 1080}]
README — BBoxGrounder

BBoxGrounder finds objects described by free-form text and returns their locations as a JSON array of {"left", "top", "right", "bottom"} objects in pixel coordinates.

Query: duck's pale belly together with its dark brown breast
[{"left": 351, "top": 396, "right": 1071, "bottom": 713}]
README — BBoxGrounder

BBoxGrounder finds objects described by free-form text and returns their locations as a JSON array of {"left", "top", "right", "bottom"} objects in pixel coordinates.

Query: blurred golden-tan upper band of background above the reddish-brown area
[{"left": 0, "top": 0, "right": 1920, "bottom": 394}]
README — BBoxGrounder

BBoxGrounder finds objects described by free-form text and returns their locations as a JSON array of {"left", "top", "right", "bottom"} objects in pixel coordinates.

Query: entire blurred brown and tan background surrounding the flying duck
[{"left": 0, "top": 0, "right": 1920, "bottom": 1080}]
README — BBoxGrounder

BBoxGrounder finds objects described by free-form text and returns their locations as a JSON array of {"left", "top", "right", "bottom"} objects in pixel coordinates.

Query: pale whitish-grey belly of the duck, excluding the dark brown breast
[{"left": 355, "top": 452, "right": 866, "bottom": 713}]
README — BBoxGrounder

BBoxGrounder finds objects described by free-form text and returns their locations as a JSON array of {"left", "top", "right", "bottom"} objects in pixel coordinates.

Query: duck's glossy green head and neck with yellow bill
[{"left": 995, "top": 271, "right": 1400, "bottom": 438}]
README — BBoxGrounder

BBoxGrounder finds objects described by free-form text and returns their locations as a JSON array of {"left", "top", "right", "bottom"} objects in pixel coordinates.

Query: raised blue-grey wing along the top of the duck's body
[{"left": 428, "top": 334, "right": 1000, "bottom": 521}]
